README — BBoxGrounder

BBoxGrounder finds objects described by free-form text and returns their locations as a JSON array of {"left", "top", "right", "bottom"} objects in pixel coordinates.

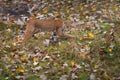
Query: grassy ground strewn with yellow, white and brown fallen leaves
[{"left": 0, "top": 0, "right": 120, "bottom": 80}]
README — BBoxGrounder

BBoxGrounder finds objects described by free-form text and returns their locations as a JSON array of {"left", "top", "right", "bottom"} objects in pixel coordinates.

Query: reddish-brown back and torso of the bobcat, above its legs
[{"left": 28, "top": 19, "right": 63, "bottom": 31}]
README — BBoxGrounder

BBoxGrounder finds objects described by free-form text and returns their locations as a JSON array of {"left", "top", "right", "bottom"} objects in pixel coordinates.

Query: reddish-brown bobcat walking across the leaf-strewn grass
[{"left": 23, "top": 19, "right": 74, "bottom": 42}]
